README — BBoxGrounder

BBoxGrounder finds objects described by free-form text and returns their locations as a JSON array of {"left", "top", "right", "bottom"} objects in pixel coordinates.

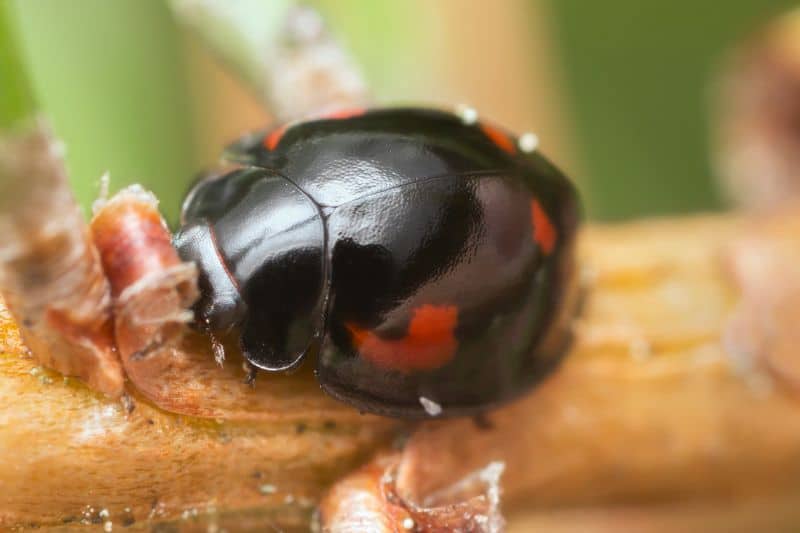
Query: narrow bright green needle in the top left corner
[{"left": 0, "top": 1, "right": 37, "bottom": 130}]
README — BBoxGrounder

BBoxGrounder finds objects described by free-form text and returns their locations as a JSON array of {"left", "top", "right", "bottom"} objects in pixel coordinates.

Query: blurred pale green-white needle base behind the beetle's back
[{"left": 170, "top": 0, "right": 370, "bottom": 121}]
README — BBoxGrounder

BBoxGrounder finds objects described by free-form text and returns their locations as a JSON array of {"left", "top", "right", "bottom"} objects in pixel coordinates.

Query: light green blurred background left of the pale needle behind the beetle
[{"left": 10, "top": 0, "right": 196, "bottom": 216}]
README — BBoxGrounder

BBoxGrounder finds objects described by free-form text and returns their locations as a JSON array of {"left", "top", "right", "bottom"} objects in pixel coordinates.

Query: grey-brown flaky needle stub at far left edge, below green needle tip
[{"left": 0, "top": 121, "right": 124, "bottom": 398}]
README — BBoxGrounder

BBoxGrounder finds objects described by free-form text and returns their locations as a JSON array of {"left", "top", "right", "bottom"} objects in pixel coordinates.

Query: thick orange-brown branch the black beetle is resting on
[{"left": 0, "top": 211, "right": 800, "bottom": 530}]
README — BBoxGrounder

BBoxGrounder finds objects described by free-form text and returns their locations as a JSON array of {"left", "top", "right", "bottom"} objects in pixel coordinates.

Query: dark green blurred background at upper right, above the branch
[{"left": 550, "top": 0, "right": 797, "bottom": 219}]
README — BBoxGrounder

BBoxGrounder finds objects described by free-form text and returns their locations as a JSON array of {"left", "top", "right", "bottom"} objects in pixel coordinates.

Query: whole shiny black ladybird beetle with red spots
[{"left": 175, "top": 109, "right": 578, "bottom": 418}]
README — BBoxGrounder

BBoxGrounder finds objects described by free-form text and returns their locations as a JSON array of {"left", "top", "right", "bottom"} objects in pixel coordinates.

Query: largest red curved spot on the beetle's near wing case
[{"left": 345, "top": 305, "right": 458, "bottom": 372}]
